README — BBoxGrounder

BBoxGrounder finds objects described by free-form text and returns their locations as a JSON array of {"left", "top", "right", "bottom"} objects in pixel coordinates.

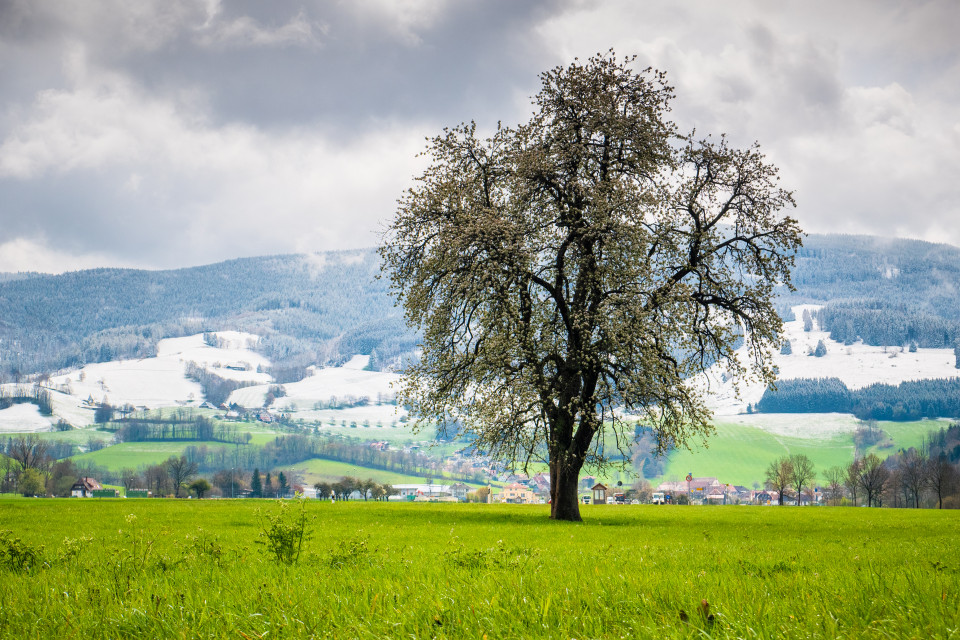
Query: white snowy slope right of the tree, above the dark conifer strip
[{"left": 696, "top": 305, "right": 960, "bottom": 420}]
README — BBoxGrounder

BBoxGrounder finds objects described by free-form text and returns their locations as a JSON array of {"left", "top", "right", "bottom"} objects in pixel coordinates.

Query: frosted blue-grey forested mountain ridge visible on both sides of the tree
[{"left": 0, "top": 235, "right": 960, "bottom": 381}]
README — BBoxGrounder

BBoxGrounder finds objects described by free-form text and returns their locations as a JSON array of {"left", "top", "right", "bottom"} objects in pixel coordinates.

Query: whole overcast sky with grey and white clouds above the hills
[{"left": 0, "top": 0, "right": 960, "bottom": 272}]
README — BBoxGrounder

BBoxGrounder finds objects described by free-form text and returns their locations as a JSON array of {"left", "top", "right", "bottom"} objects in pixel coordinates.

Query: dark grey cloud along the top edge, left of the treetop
[{"left": 1, "top": 0, "right": 557, "bottom": 129}]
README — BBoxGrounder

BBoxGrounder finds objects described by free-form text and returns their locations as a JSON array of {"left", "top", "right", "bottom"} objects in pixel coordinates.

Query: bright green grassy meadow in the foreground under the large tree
[{"left": 0, "top": 498, "right": 960, "bottom": 639}]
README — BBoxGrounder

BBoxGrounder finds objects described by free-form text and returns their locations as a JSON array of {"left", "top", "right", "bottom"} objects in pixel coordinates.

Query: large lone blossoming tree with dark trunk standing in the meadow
[{"left": 380, "top": 52, "right": 801, "bottom": 520}]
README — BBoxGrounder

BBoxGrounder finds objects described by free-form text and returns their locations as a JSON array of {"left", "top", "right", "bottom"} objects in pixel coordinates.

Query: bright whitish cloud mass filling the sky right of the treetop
[{"left": 540, "top": 2, "right": 960, "bottom": 245}]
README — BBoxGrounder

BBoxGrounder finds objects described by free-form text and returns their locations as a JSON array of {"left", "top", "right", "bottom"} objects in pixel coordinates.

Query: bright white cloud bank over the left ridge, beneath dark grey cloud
[{"left": 0, "top": 48, "right": 432, "bottom": 266}]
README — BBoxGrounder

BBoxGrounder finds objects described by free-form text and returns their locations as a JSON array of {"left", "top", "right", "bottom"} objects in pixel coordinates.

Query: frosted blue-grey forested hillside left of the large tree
[{"left": 0, "top": 250, "right": 415, "bottom": 377}]
